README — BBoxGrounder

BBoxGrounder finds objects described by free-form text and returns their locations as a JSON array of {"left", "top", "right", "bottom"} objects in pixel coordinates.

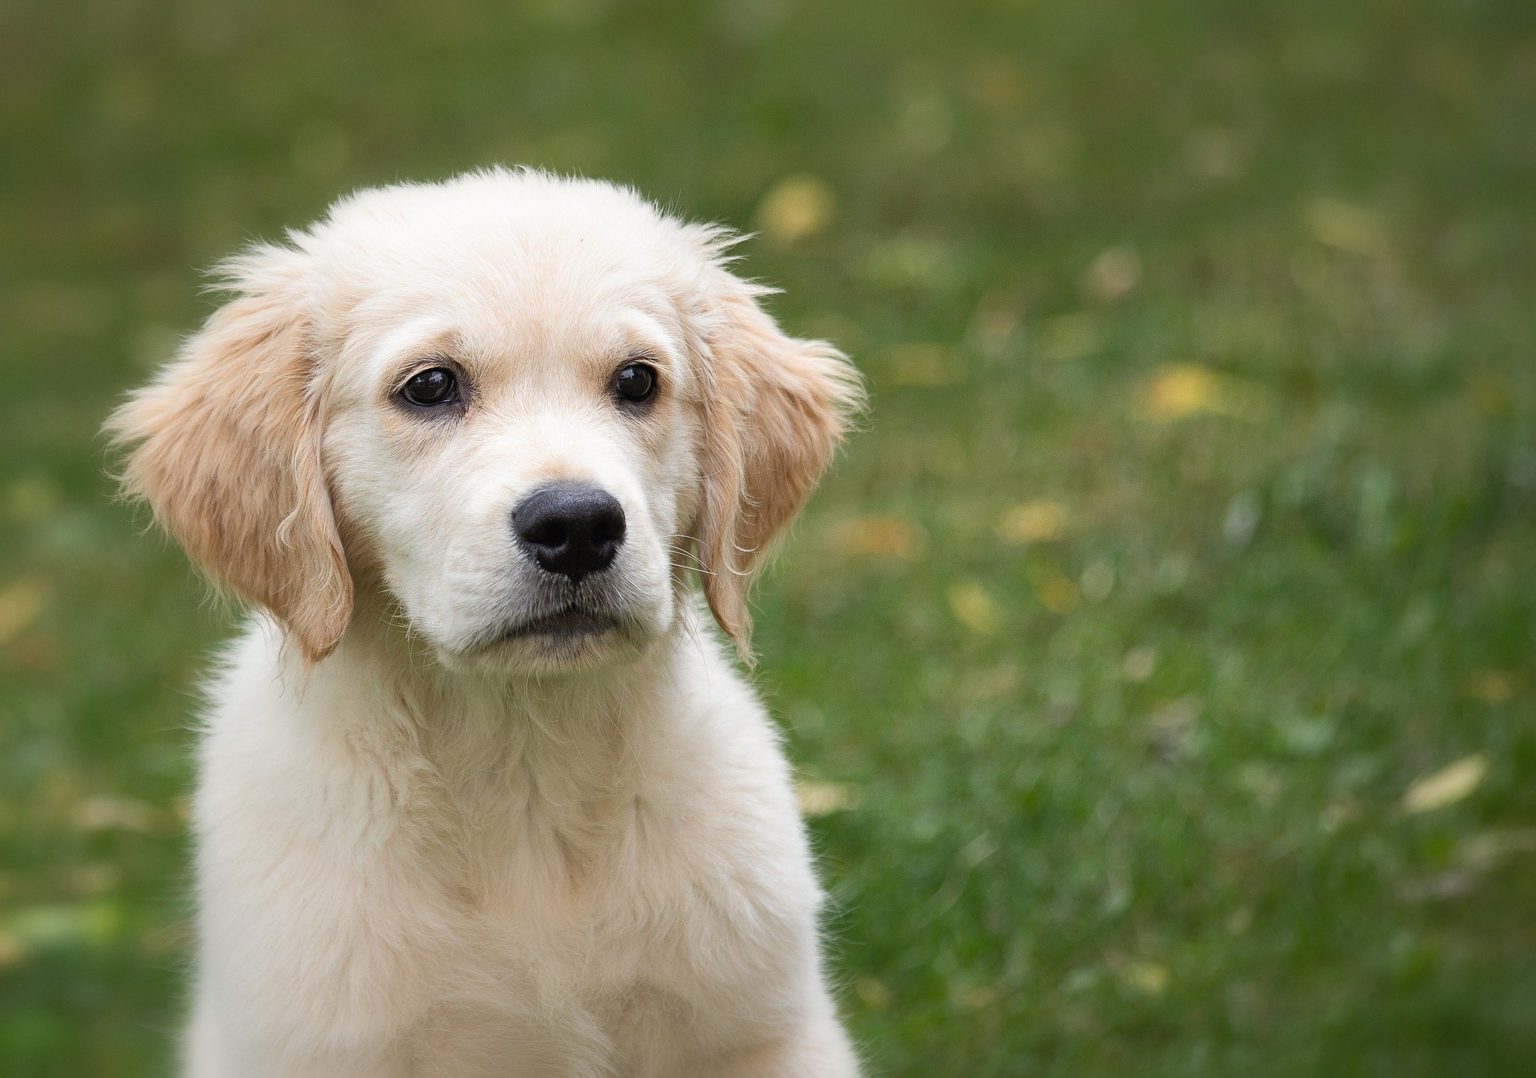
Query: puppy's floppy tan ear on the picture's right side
[{"left": 694, "top": 264, "right": 863, "bottom": 656}]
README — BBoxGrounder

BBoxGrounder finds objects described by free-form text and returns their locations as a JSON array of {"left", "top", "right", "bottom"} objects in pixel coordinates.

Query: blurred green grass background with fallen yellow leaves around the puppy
[{"left": 0, "top": 0, "right": 1536, "bottom": 1075}]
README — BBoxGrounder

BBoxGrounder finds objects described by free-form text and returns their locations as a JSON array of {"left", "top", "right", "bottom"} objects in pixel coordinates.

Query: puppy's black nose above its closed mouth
[{"left": 511, "top": 482, "right": 624, "bottom": 580}]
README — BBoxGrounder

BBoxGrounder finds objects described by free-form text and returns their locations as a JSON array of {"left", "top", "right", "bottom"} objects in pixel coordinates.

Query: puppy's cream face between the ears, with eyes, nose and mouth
[{"left": 323, "top": 207, "right": 703, "bottom": 666}]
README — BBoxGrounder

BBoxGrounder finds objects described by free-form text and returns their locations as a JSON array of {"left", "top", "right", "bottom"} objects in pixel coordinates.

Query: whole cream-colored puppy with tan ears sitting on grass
[{"left": 111, "top": 170, "right": 859, "bottom": 1078}]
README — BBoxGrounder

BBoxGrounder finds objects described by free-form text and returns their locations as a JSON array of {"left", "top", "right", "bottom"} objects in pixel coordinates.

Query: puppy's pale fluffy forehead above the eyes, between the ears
[{"left": 310, "top": 175, "right": 703, "bottom": 356}]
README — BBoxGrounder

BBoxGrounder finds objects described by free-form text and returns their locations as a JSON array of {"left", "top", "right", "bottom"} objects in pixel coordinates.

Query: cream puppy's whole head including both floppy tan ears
[{"left": 111, "top": 170, "right": 860, "bottom": 673}]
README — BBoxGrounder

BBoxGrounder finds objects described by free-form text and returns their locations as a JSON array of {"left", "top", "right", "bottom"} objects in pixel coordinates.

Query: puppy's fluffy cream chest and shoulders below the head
[{"left": 188, "top": 620, "right": 817, "bottom": 1075}]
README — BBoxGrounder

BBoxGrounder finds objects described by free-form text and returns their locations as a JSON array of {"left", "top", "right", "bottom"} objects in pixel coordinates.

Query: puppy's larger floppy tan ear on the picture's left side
[{"left": 108, "top": 247, "right": 352, "bottom": 662}]
